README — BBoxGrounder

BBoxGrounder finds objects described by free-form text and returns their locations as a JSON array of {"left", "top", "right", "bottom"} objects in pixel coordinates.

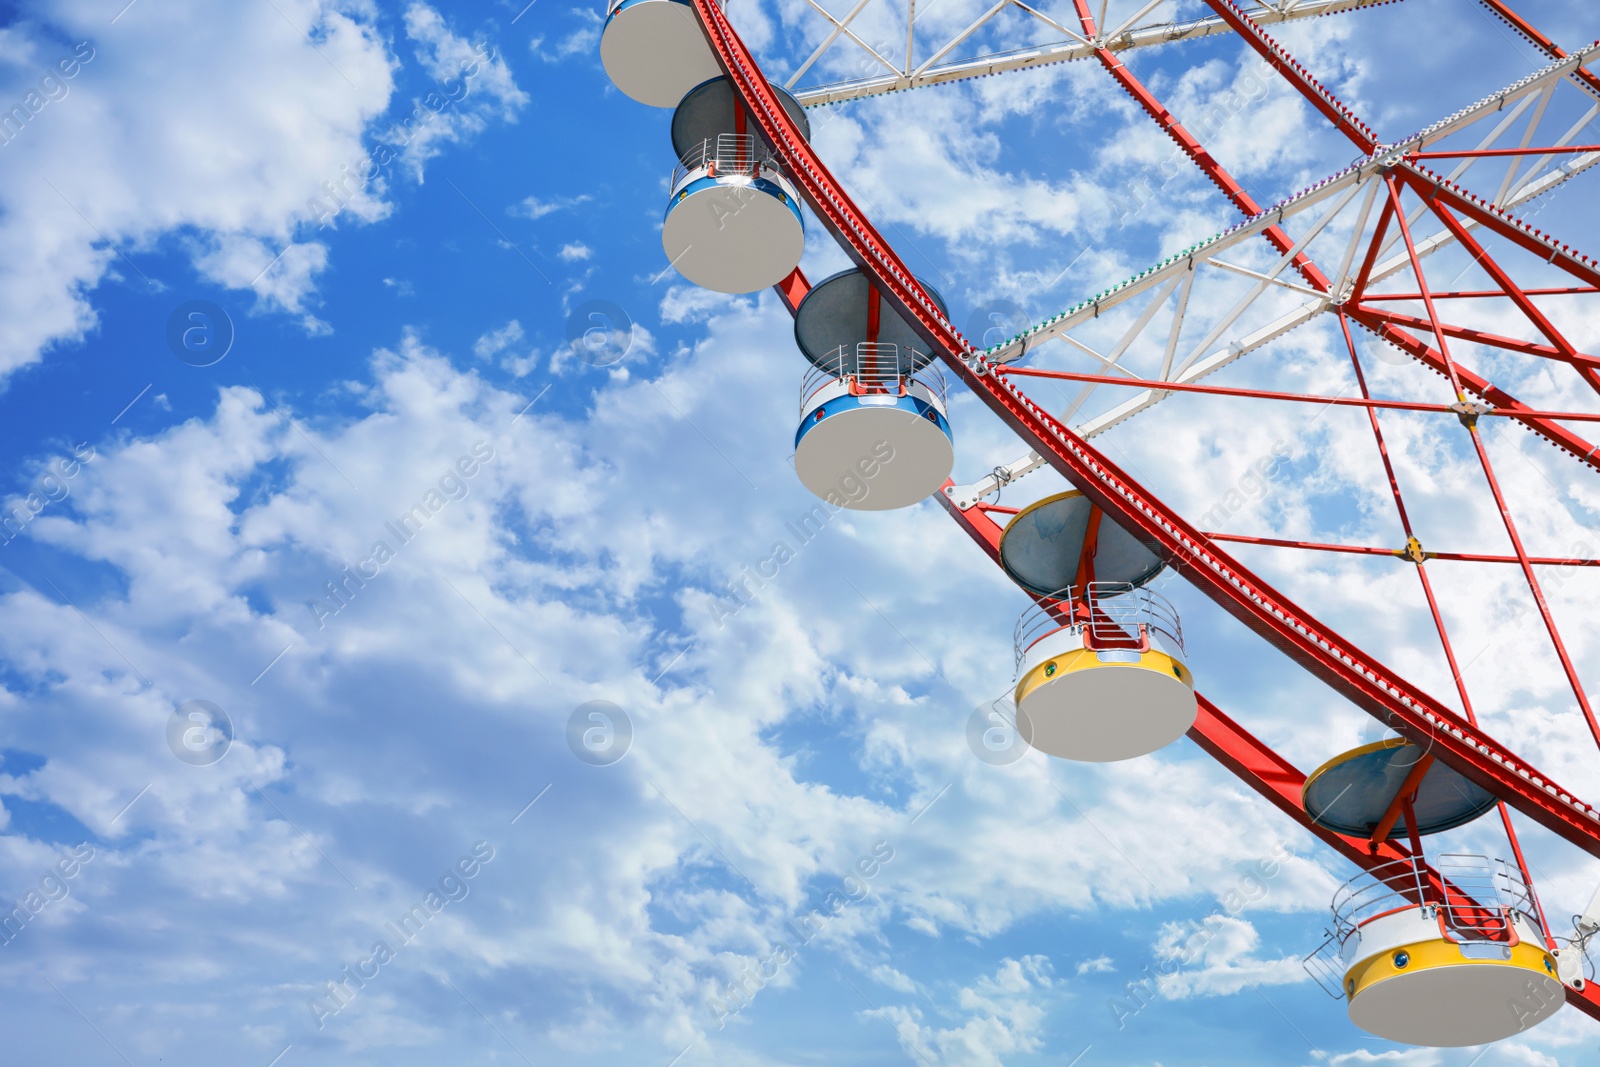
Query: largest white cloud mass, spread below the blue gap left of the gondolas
[{"left": 0, "top": 298, "right": 1337, "bottom": 1064}]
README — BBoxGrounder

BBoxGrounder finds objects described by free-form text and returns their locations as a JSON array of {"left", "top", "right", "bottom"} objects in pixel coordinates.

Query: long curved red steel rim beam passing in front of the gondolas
[{"left": 693, "top": 0, "right": 1600, "bottom": 856}]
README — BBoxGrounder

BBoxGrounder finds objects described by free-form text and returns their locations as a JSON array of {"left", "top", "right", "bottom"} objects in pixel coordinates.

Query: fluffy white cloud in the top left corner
[{"left": 0, "top": 0, "right": 392, "bottom": 383}]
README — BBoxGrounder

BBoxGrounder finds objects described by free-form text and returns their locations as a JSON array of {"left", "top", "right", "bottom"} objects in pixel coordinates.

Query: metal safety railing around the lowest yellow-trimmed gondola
[{"left": 1333, "top": 853, "right": 1536, "bottom": 944}]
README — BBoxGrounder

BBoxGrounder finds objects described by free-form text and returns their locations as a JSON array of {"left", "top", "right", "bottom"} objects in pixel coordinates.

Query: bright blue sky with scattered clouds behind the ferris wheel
[{"left": 0, "top": 0, "right": 1600, "bottom": 1067}]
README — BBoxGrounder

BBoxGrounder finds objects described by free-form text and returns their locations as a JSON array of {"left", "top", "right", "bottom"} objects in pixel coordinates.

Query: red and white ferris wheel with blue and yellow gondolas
[{"left": 600, "top": 0, "right": 1600, "bottom": 1046}]
